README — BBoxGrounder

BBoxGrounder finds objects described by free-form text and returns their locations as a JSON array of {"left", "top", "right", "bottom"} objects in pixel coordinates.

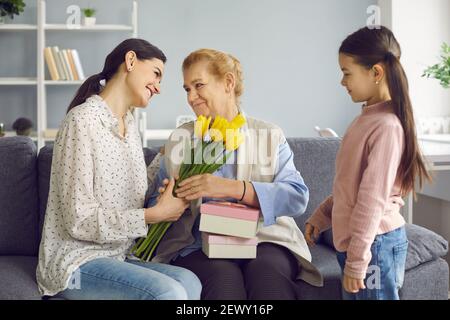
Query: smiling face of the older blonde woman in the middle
[{"left": 183, "top": 61, "right": 230, "bottom": 118}]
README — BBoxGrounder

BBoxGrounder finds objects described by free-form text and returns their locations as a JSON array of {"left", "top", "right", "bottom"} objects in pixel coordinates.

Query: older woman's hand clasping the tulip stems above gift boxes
[{"left": 175, "top": 173, "right": 236, "bottom": 201}]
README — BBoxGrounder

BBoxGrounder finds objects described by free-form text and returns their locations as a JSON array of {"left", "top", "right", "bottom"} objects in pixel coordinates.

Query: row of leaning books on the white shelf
[{"left": 44, "top": 46, "right": 84, "bottom": 81}]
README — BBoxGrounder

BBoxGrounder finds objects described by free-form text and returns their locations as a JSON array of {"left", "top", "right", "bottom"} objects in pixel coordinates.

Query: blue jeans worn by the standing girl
[{"left": 336, "top": 227, "right": 408, "bottom": 300}]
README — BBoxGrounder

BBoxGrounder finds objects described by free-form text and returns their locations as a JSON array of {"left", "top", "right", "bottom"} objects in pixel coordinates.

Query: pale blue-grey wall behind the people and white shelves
[{"left": 0, "top": 0, "right": 376, "bottom": 136}]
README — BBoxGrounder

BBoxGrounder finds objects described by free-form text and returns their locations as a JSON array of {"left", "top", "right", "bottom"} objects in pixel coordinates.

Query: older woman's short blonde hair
[{"left": 183, "top": 49, "right": 244, "bottom": 104}]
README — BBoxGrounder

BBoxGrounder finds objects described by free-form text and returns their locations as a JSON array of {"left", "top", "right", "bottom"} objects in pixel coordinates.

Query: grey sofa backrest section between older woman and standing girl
[{"left": 287, "top": 138, "right": 341, "bottom": 235}]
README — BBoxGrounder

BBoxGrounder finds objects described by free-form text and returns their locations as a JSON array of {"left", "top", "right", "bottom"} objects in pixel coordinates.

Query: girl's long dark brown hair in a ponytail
[{"left": 339, "top": 27, "right": 431, "bottom": 196}]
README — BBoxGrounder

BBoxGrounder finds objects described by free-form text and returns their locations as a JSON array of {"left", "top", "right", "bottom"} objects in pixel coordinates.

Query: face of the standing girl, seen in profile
[{"left": 339, "top": 53, "right": 377, "bottom": 102}]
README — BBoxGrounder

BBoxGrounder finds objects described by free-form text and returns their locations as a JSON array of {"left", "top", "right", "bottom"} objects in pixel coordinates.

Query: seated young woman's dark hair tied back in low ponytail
[{"left": 67, "top": 38, "right": 167, "bottom": 112}]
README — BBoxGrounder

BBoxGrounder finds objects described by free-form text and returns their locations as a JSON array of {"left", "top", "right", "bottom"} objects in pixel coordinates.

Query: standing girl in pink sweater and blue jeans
[{"left": 305, "top": 27, "right": 430, "bottom": 299}]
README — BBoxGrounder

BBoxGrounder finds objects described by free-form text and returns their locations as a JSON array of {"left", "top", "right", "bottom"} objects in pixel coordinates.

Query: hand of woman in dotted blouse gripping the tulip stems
[{"left": 145, "top": 178, "right": 189, "bottom": 224}]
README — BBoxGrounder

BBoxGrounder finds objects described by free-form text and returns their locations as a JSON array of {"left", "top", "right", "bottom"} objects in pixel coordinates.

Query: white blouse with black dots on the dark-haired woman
[{"left": 36, "top": 95, "right": 155, "bottom": 296}]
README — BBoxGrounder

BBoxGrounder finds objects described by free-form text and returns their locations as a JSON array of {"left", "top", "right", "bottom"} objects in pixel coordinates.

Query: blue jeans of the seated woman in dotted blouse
[{"left": 56, "top": 258, "right": 202, "bottom": 300}]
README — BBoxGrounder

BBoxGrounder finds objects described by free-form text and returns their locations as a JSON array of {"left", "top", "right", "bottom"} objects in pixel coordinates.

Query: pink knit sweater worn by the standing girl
[{"left": 307, "top": 101, "right": 405, "bottom": 279}]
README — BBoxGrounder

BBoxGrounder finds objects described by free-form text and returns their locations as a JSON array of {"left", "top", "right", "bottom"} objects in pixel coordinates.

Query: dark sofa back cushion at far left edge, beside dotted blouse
[{"left": 0, "top": 136, "right": 39, "bottom": 255}]
